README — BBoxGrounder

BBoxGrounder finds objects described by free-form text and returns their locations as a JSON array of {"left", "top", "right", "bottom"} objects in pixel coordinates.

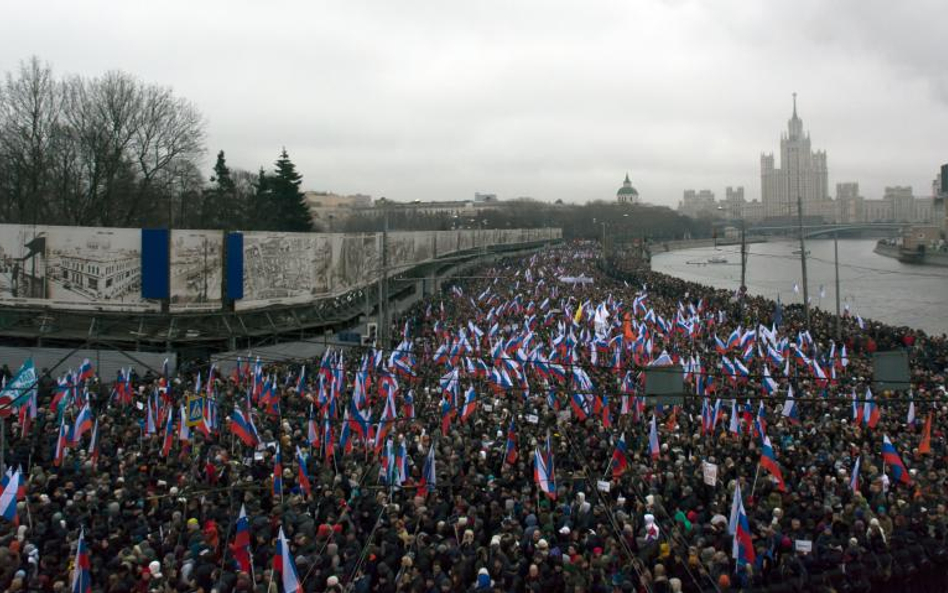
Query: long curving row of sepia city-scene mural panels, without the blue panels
[{"left": 0, "top": 224, "right": 561, "bottom": 311}]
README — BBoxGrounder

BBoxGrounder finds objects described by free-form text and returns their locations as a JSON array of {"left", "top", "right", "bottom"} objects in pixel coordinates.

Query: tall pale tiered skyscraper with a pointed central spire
[{"left": 760, "top": 93, "right": 829, "bottom": 218}]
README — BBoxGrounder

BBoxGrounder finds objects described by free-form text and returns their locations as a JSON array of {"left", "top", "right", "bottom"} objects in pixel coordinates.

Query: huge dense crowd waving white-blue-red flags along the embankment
[{"left": 0, "top": 243, "right": 948, "bottom": 593}]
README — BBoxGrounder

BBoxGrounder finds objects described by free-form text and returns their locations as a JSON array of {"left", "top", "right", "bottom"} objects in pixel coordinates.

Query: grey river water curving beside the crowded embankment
[{"left": 652, "top": 239, "right": 948, "bottom": 334}]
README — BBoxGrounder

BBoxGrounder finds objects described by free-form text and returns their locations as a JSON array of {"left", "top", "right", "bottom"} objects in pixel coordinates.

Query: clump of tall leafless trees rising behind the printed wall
[{"left": 0, "top": 58, "right": 204, "bottom": 226}]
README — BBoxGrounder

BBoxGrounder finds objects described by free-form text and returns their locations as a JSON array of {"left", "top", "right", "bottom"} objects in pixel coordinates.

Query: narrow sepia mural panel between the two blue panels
[{"left": 171, "top": 230, "right": 223, "bottom": 311}]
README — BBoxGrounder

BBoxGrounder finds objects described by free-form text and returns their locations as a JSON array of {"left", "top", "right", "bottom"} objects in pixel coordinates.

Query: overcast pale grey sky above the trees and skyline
[{"left": 0, "top": 0, "right": 948, "bottom": 206}]
